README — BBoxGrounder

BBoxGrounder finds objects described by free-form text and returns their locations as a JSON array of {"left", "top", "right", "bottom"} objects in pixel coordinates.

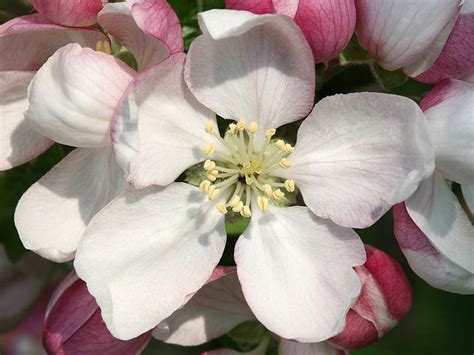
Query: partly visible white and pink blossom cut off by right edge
[{"left": 394, "top": 79, "right": 474, "bottom": 294}]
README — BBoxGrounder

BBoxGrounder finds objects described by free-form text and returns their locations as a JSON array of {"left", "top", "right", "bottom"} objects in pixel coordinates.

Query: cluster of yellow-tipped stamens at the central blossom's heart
[{"left": 199, "top": 120, "right": 295, "bottom": 217}]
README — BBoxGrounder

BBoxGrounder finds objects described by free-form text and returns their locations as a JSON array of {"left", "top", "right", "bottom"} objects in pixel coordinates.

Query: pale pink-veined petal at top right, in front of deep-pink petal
[{"left": 355, "top": 0, "right": 461, "bottom": 70}]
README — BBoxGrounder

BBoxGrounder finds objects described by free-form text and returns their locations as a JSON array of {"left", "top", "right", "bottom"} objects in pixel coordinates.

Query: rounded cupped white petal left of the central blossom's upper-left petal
[{"left": 25, "top": 44, "right": 134, "bottom": 148}]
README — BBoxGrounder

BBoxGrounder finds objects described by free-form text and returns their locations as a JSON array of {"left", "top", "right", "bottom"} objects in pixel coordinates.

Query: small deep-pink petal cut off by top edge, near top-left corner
[{"left": 32, "top": 0, "right": 107, "bottom": 27}]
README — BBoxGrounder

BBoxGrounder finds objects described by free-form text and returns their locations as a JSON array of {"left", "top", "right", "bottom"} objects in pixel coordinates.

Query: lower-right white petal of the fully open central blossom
[{"left": 235, "top": 206, "right": 365, "bottom": 342}]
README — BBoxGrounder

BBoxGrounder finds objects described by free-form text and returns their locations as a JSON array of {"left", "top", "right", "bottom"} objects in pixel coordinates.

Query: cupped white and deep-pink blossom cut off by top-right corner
[{"left": 355, "top": 0, "right": 474, "bottom": 83}]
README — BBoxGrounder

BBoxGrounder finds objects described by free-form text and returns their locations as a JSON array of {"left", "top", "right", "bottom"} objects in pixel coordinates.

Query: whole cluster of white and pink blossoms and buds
[{"left": 0, "top": 0, "right": 474, "bottom": 355}]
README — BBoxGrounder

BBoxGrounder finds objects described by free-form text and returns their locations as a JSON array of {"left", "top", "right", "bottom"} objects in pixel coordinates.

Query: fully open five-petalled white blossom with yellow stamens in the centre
[{"left": 74, "top": 10, "right": 433, "bottom": 342}]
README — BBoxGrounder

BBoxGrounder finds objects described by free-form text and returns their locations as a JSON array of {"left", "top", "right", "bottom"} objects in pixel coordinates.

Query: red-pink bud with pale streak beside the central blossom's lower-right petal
[{"left": 330, "top": 245, "right": 412, "bottom": 350}]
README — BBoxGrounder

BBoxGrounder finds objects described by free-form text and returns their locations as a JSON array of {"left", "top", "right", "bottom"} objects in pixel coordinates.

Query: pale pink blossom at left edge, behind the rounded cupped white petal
[{"left": 0, "top": 14, "right": 108, "bottom": 170}]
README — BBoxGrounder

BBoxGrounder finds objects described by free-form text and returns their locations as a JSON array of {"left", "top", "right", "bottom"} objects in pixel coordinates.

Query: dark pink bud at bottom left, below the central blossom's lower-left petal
[{"left": 43, "top": 272, "right": 151, "bottom": 355}]
